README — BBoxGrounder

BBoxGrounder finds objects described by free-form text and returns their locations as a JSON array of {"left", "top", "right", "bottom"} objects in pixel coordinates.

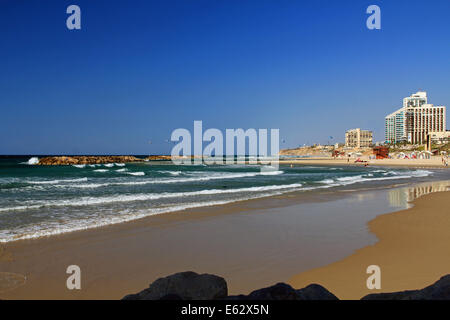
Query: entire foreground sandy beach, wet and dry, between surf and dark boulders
[{"left": 0, "top": 174, "right": 450, "bottom": 299}]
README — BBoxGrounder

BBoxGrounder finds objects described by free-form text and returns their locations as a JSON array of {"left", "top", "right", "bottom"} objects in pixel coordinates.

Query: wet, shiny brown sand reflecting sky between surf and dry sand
[{"left": 0, "top": 182, "right": 448, "bottom": 299}]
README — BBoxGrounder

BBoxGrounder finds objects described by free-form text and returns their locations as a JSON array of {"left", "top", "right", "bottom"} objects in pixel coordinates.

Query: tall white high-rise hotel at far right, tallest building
[{"left": 386, "top": 91, "right": 446, "bottom": 144}]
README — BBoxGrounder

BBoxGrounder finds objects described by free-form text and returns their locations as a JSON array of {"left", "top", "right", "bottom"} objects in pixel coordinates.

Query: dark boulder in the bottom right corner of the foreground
[{"left": 361, "top": 275, "right": 450, "bottom": 300}]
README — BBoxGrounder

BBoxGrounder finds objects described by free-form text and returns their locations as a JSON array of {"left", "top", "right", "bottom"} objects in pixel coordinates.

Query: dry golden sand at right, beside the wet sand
[{"left": 289, "top": 191, "right": 450, "bottom": 299}]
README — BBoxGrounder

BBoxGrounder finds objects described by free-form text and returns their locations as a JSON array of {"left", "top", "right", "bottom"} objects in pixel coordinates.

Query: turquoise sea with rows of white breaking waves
[{"left": 0, "top": 157, "right": 436, "bottom": 242}]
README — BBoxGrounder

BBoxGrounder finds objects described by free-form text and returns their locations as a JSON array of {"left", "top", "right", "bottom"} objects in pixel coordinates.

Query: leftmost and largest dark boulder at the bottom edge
[{"left": 123, "top": 271, "right": 228, "bottom": 300}]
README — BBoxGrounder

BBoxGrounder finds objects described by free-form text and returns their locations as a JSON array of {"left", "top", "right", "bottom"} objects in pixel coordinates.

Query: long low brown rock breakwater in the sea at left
[{"left": 37, "top": 156, "right": 143, "bottom": 166}]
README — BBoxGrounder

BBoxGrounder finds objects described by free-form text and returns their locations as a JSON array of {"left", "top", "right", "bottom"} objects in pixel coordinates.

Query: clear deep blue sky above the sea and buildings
[{"left": 0, "top": 0, "right": 450, "bottom": 154}]
